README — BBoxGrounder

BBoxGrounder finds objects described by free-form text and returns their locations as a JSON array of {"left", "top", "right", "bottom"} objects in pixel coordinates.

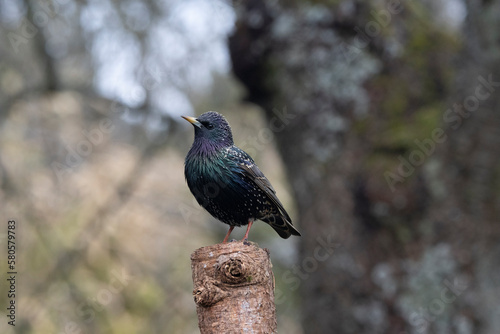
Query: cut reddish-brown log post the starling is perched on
[{"left": 191, "top": 241, "right": 277, "bottom": 334}]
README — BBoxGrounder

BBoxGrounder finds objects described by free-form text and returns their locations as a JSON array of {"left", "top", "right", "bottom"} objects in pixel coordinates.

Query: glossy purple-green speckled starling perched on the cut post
[{"left": 181, "top": 111, "right": 300, "bottom": 243}]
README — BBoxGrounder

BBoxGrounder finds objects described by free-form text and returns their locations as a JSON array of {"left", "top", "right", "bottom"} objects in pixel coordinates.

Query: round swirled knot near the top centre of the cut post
[{"left": 217, "top": 254, "right": 255, "bottom": 284}]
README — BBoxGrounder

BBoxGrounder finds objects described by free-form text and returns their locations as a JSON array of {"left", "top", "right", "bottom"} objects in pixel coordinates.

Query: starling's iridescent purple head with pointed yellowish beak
[{"left": 182, "top": 111, "right": 233, "bottom": 148}]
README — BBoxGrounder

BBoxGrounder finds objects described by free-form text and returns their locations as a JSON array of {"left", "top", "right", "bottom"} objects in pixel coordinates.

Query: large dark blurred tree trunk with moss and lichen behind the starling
[{"left": 229, "top": 0, "right": 500, "bottom": 333}]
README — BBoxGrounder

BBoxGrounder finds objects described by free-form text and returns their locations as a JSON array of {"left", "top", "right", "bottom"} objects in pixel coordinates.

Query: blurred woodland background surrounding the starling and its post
[{"left": 0, "top": 0, "right": 500, "bottom": 334}]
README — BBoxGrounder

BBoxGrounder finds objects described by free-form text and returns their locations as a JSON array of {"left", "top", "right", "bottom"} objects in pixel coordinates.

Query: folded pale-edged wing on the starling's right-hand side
[{"left": 228, "top": 149, "right": 292, "bottom": 222}]
